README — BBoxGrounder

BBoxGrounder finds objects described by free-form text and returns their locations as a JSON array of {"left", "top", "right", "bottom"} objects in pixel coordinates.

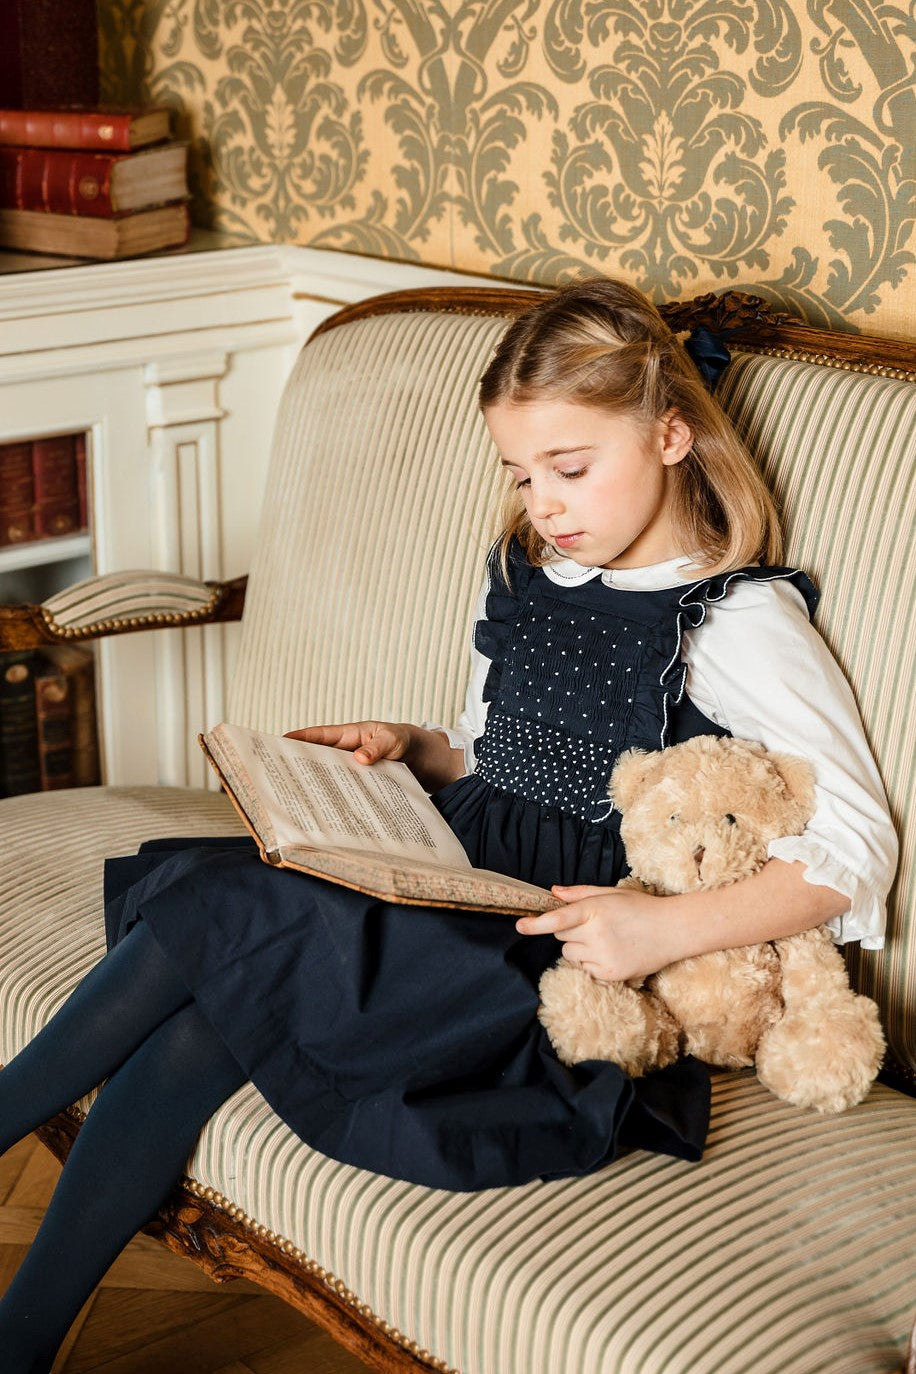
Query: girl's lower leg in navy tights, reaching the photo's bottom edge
[{"left": 0, "top": 1003, "right": 246, "bottom": 1374}]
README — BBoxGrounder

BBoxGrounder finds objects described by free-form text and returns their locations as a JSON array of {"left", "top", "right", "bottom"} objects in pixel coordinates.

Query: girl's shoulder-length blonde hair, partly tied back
[{"left": 479, "top": 278, "right": 783, "bottom": 573}]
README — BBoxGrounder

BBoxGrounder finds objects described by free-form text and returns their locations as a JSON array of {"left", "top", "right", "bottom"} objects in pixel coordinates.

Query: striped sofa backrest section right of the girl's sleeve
[{"left": 717, "top": 354, "right": 916, "bottom": 1072}]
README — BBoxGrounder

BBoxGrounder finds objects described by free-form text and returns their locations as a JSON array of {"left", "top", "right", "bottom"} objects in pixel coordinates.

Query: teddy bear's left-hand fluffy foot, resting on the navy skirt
[{"left": 537, "top": 959, "right": 677, "bottom": 1077}]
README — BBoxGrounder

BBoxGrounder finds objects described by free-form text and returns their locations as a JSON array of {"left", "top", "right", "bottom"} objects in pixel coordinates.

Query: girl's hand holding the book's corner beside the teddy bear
[{"left": 515, "top": 886, "right": 681, "bottom": 982}]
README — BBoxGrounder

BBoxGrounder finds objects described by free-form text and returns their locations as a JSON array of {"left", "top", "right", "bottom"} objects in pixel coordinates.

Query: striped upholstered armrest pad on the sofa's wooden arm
[{"left": 41, "top": 570, "right": 221, "bottom": 633}]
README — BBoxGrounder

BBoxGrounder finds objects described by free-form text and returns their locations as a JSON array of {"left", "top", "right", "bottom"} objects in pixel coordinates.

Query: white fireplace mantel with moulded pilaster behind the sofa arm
[{"left": 0, "top": 232, "right": 505, "bottom": 786}]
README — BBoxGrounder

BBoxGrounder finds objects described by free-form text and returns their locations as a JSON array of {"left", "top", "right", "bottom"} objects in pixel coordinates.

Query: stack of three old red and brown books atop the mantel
[{"left": 0, "top": 106, "right": 190, "bottom": 258}]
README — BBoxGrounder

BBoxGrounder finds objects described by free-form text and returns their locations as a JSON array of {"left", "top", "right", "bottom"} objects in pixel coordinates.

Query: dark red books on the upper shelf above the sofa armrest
[{"left": 0, "top": 434, "right": 89, "bottom": 547}]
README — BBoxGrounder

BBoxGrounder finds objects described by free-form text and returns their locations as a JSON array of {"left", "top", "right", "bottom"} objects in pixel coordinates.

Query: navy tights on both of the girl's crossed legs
[{"left": 0, "top": 923, "right": 246, "bottom": 1374}]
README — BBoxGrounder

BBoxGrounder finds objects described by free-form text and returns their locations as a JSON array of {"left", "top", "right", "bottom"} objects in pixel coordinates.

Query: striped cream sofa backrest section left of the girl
[{"left": 222, "top": 315, "right": 504, "bottom": 730}]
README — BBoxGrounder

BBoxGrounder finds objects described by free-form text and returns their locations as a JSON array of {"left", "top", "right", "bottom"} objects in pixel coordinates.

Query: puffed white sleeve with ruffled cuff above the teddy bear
[{"left": 684, "top": 580, "right": 898, "bottom": 949}]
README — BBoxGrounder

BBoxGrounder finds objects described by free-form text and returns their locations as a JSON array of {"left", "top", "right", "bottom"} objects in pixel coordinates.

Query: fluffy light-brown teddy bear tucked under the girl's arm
[{"left": 538, "top": 735, "right": 884, "bottom": 1113}]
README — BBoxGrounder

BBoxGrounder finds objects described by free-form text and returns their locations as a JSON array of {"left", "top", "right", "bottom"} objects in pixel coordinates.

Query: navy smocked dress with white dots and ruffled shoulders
[{"left": 106, "top": 548, "right": 813, "bottom": 1190}]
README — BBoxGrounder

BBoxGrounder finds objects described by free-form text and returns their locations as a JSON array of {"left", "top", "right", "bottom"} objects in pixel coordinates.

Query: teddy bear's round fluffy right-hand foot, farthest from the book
[{"left": 757, "top": 993, "right": 884, "bottom": 1114}]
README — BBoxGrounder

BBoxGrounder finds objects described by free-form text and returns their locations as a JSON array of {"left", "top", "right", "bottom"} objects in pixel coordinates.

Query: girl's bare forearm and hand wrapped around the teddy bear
[{"left": 516, "top": 859, "right": 849, "bottom": 981}]
